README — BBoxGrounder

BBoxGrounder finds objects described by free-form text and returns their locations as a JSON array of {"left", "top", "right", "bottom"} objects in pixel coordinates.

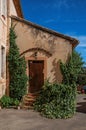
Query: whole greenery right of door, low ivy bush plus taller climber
[{"left": 34, "top": 51, "right": 83, "bottom": 118}]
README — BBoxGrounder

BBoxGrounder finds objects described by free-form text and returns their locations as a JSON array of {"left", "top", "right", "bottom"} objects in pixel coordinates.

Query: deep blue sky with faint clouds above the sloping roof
[{"left": 21, "top": 0, "right": 86, "bottom": 62}]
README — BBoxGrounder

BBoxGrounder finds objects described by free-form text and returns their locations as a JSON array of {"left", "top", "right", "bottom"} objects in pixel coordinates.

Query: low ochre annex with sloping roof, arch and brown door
[{"left": 11, "top": 16, "right": 78, "bottom": 92}]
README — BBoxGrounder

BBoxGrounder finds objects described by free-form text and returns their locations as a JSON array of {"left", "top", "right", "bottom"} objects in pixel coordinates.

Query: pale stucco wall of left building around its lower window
[{"left": 0, "top": 5, "right": 7, "bottom": 97}]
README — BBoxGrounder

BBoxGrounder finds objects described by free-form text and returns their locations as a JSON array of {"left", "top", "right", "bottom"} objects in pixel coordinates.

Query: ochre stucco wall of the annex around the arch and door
[{"left": 12, "top": 19, "right": 72, "bottom": 82}]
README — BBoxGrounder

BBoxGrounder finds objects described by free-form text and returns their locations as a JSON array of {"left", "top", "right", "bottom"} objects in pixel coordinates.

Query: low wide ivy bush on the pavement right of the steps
[{"left": 34, "top": 82, "right": 76, "bottom": 118}]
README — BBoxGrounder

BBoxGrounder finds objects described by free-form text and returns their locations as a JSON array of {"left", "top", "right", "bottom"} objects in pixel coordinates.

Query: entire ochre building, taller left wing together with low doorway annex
[{"left": 0, "top": 0, "right": 78, "bottom": 97}]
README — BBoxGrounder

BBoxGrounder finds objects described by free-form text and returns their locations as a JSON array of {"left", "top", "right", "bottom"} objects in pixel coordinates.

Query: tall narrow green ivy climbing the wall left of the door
[{"left": 8, "top": 27, "right": 27, "bottom": 100}]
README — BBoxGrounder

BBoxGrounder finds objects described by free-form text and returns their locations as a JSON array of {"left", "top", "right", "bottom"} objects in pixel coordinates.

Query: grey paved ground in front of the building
[{"left": 0, "top": 95, "right": 86, "bottom": 130}]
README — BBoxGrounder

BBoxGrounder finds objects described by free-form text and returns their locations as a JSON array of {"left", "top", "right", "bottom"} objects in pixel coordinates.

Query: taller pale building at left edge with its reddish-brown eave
[{"left": 0, "top": 0, "right": 23, "bottom": 97}]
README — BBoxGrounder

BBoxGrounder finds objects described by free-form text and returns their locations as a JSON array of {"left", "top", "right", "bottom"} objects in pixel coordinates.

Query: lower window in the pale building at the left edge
[{"left": 1, "top": 46, "right": 5, "bottom": 78}]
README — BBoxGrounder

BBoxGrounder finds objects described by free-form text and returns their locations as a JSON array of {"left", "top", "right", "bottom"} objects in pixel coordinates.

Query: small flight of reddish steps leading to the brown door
[{"left": 21, "top": 93, "right": 38, "bottom": 109}]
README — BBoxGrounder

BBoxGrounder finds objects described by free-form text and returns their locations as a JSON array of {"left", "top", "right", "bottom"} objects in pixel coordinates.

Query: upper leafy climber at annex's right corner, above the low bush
[{"left": 60, "top": 51, "right": 84, "bottom": 84}]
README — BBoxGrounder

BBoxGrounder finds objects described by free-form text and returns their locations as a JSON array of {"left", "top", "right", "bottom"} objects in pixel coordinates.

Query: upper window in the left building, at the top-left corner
[{"left": 0, "top": 0, "right": 7, "bottom": 19}]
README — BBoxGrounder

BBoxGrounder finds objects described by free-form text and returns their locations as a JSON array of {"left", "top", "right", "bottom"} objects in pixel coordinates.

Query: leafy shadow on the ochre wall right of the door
[{"left": 51, "top": 58, "right": 62, "bottom": 83}]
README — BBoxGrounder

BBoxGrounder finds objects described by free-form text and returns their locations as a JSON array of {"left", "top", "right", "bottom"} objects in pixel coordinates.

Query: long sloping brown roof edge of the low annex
[{"left": 10, "top": 15, "right": 79, "bottom": 48}]
